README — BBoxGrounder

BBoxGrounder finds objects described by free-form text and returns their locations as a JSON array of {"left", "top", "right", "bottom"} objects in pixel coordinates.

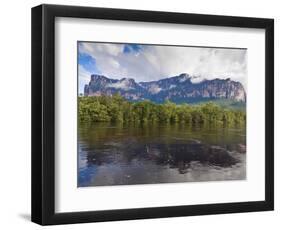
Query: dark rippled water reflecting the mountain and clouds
[{"left": 78, "top": 123, "right": 246, "bottom": 187}]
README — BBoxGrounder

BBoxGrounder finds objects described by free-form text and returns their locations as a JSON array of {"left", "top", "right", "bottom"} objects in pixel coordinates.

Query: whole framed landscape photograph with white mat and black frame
[{"left": 32, "top": 5, "right": 274, "bottom": 225}]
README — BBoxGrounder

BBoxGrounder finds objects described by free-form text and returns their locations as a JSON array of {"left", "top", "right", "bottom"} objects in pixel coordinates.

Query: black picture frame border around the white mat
[{"left": 31, "top": 5, "right": 274, "bottom": 225}]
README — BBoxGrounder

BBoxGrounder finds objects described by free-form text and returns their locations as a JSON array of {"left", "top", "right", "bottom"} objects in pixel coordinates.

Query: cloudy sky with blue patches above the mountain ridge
[{"left": 78, "top": 42, "right": 247, "bottom": 93}]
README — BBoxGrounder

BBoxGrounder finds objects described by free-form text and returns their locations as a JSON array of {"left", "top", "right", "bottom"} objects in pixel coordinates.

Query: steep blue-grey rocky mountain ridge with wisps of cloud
[{"left": 84, "top": 73, "right": 246, "bottom": 103}]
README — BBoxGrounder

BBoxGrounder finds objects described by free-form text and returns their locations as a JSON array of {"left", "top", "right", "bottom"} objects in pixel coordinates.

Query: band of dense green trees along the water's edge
[{"left": 78, "top": 94, "right": 246, "bottom": 125}]
